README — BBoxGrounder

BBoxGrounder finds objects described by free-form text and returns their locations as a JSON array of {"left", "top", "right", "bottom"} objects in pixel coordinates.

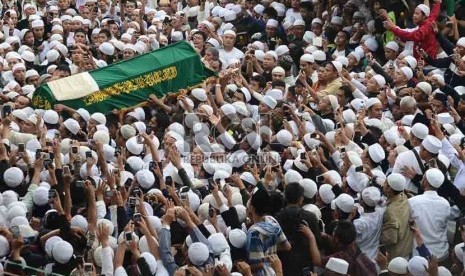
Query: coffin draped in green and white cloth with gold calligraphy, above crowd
[{"left": 32, "top": 41, "right": 215, "bottom": 114}]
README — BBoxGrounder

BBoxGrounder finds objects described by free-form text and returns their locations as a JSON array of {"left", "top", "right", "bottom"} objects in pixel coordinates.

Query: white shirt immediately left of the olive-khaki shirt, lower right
[{"left": 354, "top": 208, "right": 385, "bottom": 261}]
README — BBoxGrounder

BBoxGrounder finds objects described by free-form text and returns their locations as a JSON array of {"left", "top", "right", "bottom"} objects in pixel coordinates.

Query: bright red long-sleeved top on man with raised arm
[{"left": 391, "top": 2, "right": 441, "bottom": 59}]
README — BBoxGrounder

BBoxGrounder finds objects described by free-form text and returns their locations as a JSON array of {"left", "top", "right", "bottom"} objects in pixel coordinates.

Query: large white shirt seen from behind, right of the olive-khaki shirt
[{"left": 408, "top": 191, "right": 450, "bottom": 260}]
